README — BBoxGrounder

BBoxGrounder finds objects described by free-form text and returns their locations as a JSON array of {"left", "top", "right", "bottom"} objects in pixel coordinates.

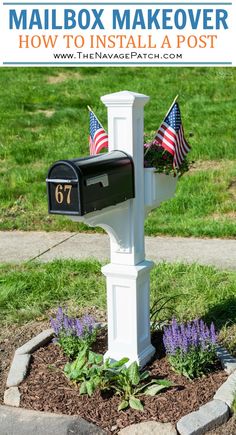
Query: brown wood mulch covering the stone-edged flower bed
[{"left": 20, "top": 333, "right": 227, "bottom": 434}]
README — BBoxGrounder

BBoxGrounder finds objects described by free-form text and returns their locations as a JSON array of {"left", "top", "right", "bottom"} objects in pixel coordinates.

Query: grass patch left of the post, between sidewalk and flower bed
[{"left": 0, "top": 260, "right": 106, "bottom": 324}]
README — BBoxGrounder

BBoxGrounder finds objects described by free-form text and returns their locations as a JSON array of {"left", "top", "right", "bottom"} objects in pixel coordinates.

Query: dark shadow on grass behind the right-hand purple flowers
[{"left": 203, "top": 296, "right": 236, "bottom": 330}]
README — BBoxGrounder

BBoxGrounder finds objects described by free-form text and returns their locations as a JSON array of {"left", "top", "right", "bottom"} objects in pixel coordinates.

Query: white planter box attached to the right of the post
[{"left": 144, "top": 168, "right": 178, "bottom": 209}]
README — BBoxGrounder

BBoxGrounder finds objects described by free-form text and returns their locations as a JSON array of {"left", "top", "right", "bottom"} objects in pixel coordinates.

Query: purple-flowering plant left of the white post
[{"left": 50, "top": 307, "right": 97, "bottom": 358}]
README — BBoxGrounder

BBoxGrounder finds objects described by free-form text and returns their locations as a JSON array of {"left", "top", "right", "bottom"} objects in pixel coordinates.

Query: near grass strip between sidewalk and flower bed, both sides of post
[{"left": 0, "top": 260, "right": 236, "bottom": 329}]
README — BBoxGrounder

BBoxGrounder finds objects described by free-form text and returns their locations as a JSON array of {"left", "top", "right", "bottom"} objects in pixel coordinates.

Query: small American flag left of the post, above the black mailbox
[{"left": 89, "top": 110, "right": 108, "bottom": 156}]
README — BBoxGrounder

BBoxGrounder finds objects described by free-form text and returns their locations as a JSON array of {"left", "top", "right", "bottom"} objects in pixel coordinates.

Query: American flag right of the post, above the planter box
[{"left": 155, "top": 103, "right": 190, "bottom": 169}]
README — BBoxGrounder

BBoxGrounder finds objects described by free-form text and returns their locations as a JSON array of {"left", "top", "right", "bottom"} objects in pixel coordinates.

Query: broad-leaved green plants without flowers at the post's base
[{"left": 64, "top": 349, "right": 172, "bottom": 411}]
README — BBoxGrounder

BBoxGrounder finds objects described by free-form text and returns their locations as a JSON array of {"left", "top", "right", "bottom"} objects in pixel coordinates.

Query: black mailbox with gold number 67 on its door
[{"left": 46, "top": 151, "right": 134, "bottom": 216}]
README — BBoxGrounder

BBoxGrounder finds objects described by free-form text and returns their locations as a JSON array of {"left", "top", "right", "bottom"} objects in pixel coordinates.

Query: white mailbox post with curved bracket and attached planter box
[{"left": 60, "top": 91, "right": 176, "bottom": 367}]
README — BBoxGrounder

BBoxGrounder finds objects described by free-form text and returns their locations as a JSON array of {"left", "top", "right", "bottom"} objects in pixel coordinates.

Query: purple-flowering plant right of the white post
[{"left": 163, "top": 319, "right": 216, "bottom": 379}]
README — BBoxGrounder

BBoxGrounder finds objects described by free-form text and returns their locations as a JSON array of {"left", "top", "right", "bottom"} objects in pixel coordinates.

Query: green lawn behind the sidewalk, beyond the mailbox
[{"left": 0, "top": 68, "right": 236, "bottom": 237}]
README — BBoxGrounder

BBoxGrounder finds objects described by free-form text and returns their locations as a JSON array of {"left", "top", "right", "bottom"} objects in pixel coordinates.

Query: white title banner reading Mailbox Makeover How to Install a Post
[{"left": 0, "top": 1, "right": 236, "bottom": 66}]
